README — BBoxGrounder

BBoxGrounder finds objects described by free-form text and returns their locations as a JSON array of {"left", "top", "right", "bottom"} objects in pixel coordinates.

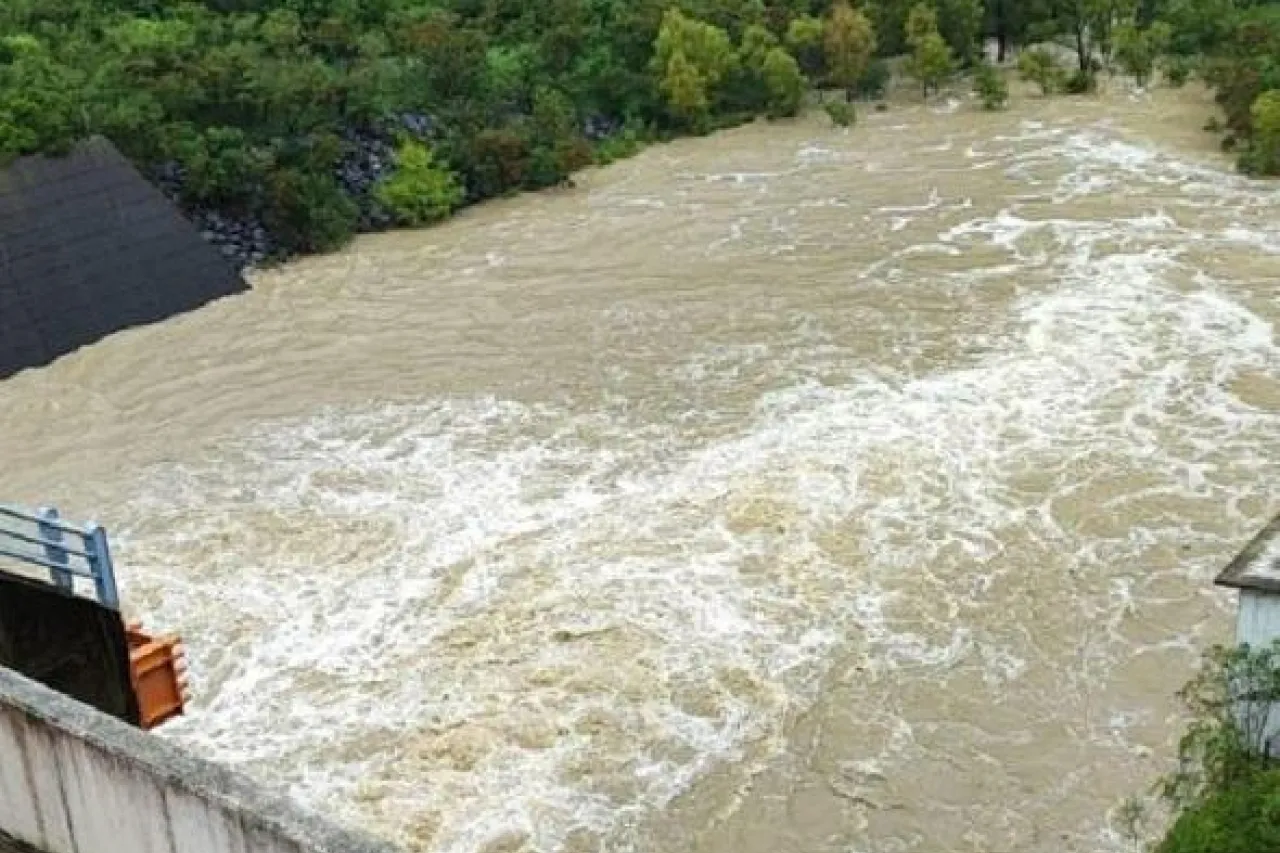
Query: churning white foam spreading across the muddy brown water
[{"left": 110, "top": 114, "right": 1280, "bottom": 853}]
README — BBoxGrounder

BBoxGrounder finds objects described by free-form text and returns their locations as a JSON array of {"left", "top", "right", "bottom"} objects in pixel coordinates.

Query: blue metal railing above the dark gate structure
[{"left": 0, "top": 503, "right": 120, "bottom": 610}]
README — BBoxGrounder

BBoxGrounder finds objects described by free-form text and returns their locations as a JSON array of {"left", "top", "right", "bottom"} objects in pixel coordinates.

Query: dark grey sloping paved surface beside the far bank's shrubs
[{"left": 0, "top": 137, "right": 247, "bottom": 378}]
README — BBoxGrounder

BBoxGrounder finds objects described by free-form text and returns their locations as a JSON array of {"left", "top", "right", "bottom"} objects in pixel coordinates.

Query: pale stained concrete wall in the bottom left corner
[{"left": 0, "top": 669, "right": 394, "bottom": 853}]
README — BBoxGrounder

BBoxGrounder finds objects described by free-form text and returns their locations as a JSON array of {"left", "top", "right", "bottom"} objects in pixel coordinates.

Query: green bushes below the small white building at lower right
[{"left": 1155, "top": 642, "right": 1280, "bottom": 853}]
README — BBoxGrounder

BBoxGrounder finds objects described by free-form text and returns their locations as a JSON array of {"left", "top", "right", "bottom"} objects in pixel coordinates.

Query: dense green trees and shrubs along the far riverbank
[{"left": 0, "top": 0, "right": 1280, "bottom": 263}]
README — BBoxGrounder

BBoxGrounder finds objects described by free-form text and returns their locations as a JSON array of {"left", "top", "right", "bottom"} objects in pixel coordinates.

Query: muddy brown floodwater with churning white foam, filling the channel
[{"left": 0, "top": 81, "right": 1280, "bottom": 853}]
